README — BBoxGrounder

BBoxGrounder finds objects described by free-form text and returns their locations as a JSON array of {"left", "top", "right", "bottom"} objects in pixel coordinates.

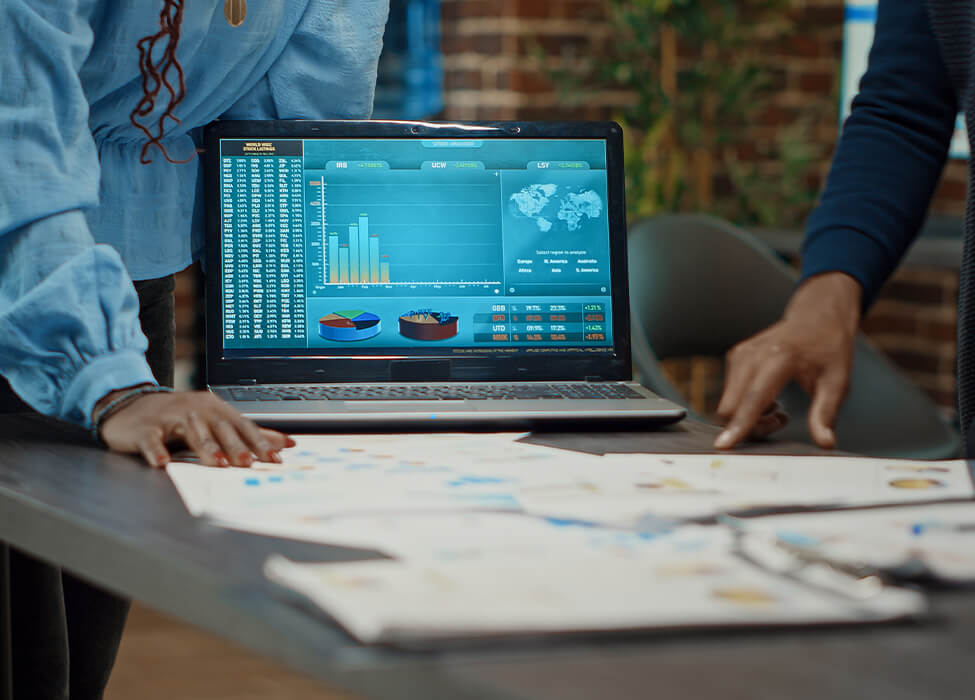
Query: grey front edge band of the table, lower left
[{"left": 0, "top": 460, "right": 532, "bottom": 700}]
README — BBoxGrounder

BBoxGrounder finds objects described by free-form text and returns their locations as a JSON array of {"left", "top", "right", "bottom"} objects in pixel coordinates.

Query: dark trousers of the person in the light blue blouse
[{"left": 0, "top": 275, "right": 173, "bottom": 700}]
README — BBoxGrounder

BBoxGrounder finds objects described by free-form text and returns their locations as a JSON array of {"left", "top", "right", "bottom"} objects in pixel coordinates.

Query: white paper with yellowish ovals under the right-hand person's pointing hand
[{"left": 519, "top": 454, "right": 975, "bottom": 527}]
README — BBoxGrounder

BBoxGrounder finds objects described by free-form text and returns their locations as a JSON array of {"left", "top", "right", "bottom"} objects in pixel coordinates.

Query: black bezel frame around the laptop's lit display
[{"left": 204, "top": 120, "right": 632, "bottom": 386}]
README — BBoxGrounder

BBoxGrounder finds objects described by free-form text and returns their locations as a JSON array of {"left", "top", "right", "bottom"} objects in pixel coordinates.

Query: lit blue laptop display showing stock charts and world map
[{"left": 219, "top": 138, "right": 613, "bottom": 356}]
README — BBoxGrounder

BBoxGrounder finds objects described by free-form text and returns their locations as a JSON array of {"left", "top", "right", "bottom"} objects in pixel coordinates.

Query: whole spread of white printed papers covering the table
[{"left": 168, "top": 434, "right": 975, "bottom": 642}]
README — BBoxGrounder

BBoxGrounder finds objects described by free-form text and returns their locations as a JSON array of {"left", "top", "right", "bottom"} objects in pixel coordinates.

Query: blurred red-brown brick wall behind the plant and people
[{"left": 177, "top": 0, "right": 967, "bottom": 422}]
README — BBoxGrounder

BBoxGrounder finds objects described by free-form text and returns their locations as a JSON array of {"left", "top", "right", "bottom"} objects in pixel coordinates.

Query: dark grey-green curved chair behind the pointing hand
[{"left": 628, "top": 214, "right": 961, "bottom": 459}]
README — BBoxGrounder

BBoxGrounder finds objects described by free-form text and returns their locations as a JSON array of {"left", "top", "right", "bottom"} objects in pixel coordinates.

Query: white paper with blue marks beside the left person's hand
[{"left": 167, "top": 434, "right": 584, "bottom": 520}]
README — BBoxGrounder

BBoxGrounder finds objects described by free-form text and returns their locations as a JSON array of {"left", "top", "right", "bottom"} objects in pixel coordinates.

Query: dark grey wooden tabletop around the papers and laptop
[{"left": 0, "top": 416, "right": 975, "bottom": 700}]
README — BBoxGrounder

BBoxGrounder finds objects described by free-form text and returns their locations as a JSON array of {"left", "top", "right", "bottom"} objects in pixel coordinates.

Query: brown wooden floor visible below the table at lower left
[{"left": 105, "top": 604, "right": 353, "bottom": 700}]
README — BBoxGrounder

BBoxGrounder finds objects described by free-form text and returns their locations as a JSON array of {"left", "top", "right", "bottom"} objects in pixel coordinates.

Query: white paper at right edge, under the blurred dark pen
[{"left": 735, "top": 502, "right": 975, "bottom": 584}]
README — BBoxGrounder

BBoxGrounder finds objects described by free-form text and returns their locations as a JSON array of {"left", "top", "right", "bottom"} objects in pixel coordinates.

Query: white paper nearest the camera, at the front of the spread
[{"left": 265, "top": 516, "right": 925, "bottom": 643}]
